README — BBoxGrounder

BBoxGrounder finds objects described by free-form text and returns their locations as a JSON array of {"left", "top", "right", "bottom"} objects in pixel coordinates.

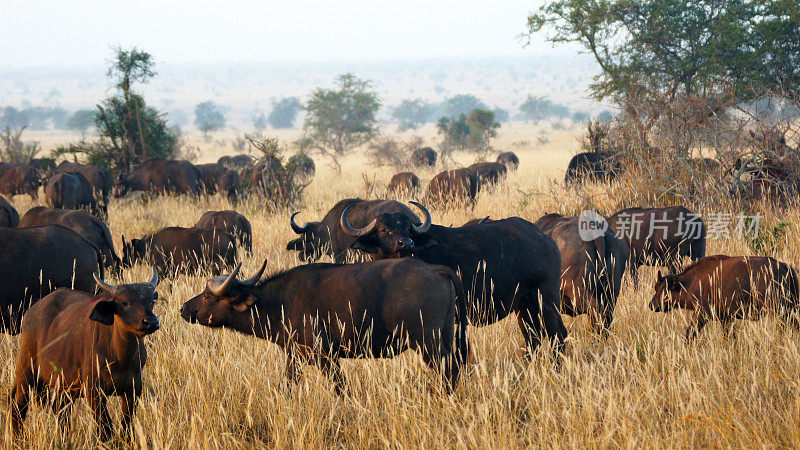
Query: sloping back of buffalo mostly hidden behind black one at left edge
[{"left": 19, "top": 206, "right": 122, "bottom": 276}]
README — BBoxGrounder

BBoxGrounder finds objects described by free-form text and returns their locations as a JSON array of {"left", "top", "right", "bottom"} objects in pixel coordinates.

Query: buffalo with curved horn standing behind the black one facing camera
[{"left": 286, "top": 198, "right": 420, "bottom": 263}]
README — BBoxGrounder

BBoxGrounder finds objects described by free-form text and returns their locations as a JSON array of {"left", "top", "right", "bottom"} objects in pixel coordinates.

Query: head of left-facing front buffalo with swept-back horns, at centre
[{"left": 180, "top": 260, "right": 267, "bottom": 333}]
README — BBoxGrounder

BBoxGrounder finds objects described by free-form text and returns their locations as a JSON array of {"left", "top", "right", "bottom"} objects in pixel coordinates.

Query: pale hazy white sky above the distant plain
[{"left": 0, "top": 0, "right": 564, "bottom": 67}]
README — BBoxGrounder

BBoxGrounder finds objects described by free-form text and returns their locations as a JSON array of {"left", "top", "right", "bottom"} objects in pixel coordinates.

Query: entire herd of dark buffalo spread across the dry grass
[{"left": 0, "top": 149, "right": 800, "bottom": 439}]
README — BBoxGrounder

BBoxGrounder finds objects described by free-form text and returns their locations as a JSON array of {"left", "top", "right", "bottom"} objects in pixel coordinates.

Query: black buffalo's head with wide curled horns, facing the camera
[{"left": 340, "top": 202, "right": 436, "bottom": 258}]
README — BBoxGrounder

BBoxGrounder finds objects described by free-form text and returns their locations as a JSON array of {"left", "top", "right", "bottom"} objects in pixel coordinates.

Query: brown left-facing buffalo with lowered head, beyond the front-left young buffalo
[{"left": 122, "top": 227, "right": 236, "bottom": 276}]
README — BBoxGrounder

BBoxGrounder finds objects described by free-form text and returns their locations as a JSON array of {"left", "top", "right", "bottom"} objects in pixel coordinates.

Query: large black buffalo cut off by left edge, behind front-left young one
[{"left": 0, "top": 225, "right": 103, "bottom": 334}]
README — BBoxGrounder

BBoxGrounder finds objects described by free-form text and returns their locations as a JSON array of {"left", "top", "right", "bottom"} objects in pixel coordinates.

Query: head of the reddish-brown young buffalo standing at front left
[{"left": 89, "top": 267, "right": 160, "bottom": 335}]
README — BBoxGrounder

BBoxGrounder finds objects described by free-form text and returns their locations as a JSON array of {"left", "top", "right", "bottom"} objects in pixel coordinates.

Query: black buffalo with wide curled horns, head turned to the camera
[{"left": 342, "top": 205, "right": 567, "bottom": 351}]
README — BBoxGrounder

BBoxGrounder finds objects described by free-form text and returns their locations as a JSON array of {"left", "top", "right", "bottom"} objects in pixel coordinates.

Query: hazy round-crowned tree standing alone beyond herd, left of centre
[{"left": 299, "top": 73, "right": 381, "bottom": 173}]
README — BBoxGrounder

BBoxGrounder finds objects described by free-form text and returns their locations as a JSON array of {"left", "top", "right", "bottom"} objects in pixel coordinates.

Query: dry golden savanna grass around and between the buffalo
[{"left": 0, "top": 124, "right": 800, "bottom": 448}]
